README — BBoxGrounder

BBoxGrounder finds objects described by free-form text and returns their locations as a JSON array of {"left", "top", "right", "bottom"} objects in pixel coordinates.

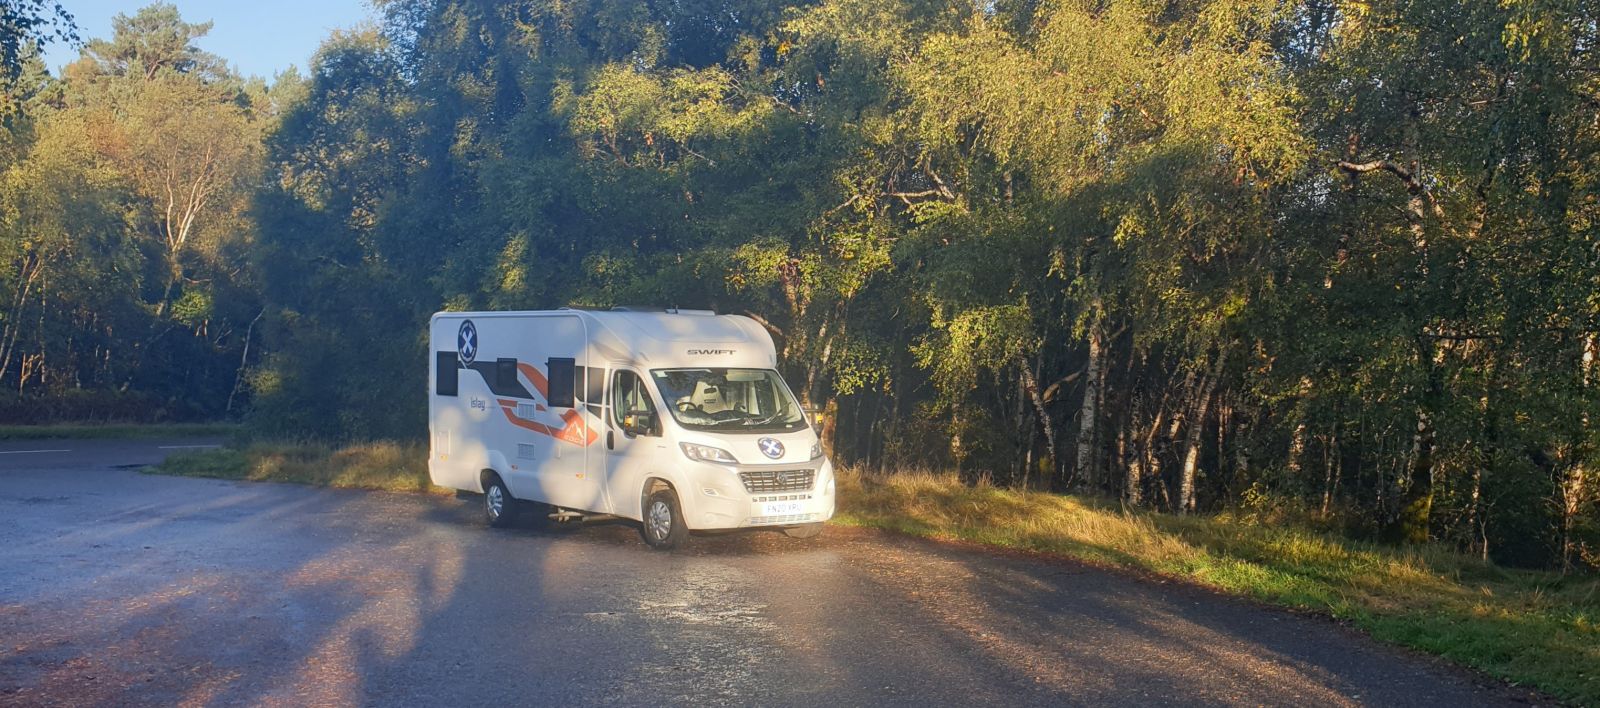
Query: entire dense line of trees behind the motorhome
[{"left": 0, "top": 0, "right": 1600, "bottom": 567}]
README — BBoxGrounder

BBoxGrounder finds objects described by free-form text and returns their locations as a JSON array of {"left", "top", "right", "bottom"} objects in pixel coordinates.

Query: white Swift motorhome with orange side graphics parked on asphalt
[{"left": 427, "top": 309, "right": 834, "bottom": 548}]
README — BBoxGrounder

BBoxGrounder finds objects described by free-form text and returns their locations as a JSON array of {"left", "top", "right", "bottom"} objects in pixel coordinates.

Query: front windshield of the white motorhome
[{"left": 650, "top": 368, "right": 805, "bottom": 432}]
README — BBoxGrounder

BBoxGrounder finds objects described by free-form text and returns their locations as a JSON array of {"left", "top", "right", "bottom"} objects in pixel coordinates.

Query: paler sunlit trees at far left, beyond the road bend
[{"left": 0, "top": 3, "right": 275, "bottom": 423}]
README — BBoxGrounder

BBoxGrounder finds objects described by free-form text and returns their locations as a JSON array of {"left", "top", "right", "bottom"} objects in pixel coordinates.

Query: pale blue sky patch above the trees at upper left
[{"left": 45, "top": 0, "right": 373, "bottom": 78}]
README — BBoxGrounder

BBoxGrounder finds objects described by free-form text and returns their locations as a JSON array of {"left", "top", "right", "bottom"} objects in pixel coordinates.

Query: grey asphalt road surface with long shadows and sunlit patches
[{"left": 0, "top": 440, "right": 1533, "bottom": 706}]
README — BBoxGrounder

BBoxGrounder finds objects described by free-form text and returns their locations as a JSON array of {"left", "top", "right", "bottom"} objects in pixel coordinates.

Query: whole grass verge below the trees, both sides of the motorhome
[{"left": 154, "top": 442, "right": 1600, "bottom": 705}]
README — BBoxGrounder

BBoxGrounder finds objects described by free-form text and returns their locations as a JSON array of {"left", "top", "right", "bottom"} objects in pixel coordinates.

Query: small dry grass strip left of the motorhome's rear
[{"left": 147, "top": 442, "right": 448, "bottom": 493}]
